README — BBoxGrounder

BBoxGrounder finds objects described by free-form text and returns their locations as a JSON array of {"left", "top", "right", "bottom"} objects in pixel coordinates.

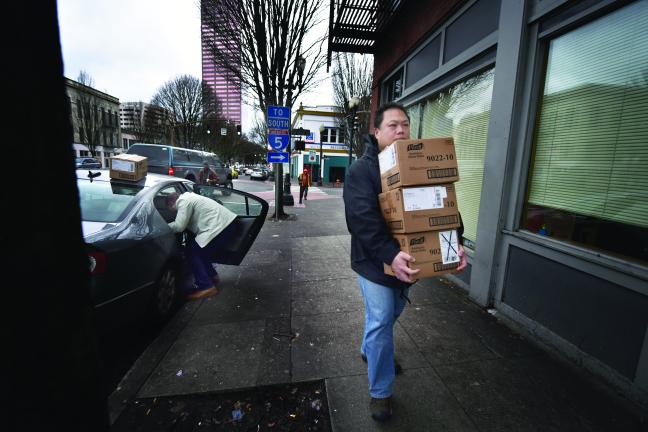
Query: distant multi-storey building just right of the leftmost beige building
[{"left": 119, "top": 102, "right": 171, "bottom": 148}]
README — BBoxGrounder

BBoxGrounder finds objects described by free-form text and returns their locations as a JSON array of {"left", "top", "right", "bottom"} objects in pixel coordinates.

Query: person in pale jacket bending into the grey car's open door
[{"left": 167, "top": 192, "right": 236, "bottom": 300}]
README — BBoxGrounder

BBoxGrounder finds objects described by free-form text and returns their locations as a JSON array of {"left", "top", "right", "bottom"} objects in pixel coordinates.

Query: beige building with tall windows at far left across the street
[{"left": 65, "top": 78, "right": 123, "bottom": 166}]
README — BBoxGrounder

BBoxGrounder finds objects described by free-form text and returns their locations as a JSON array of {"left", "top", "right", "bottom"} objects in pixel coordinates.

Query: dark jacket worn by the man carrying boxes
[{"left": 344, "top": 135, "right": 411, "bottom": 289}]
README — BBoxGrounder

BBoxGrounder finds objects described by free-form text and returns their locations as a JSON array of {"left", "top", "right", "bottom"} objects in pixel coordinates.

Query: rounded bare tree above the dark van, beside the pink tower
[{"left": 151, "top": 75, "right": 203, "bottom": 148}]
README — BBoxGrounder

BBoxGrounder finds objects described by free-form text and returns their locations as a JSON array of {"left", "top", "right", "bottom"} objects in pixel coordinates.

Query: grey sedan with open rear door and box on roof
[{"left": 77, "top": 170, "right": 268, "bottom": 330}]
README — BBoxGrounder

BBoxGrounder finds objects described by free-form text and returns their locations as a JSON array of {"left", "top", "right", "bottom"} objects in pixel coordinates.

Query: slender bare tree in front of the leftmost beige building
[{"left": 75, "top": 70, "right": 104, "bottom": 157}]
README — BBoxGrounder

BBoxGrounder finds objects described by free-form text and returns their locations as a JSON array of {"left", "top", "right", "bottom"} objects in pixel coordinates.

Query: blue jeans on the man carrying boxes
[{"left": 358, "top": 276, "right": 409, "bottom": 398}]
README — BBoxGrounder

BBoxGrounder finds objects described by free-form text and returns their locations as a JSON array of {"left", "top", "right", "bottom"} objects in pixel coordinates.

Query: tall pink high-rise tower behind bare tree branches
[{"left": 201, "top": 6, "right": 242, "bottom": 125}]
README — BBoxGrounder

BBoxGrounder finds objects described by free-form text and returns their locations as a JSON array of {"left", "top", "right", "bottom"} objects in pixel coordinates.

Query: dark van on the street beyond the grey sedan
[{"left": 126, "top": 143, "right": 234, "bottom": 189}]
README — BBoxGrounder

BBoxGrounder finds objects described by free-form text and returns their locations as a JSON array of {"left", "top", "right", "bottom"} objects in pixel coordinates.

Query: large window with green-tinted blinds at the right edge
[{"left": 522, "top": 2, "right": 648, "bottom": 264}]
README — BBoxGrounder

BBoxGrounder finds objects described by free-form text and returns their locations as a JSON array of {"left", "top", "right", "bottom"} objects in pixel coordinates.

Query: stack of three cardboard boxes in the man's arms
[{"left": 378, "top": 138, "right": 461, "bottom": 278}]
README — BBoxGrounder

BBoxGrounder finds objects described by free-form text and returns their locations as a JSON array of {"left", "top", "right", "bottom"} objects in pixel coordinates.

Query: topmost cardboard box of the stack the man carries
[{"left": 378, "top": 137, "right": 459, "bottom": 192}]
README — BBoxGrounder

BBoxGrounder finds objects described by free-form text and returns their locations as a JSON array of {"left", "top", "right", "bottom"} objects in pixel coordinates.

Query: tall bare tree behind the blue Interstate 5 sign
[{"left": 200, "top": 0, "right": 326, "bottom": 218}]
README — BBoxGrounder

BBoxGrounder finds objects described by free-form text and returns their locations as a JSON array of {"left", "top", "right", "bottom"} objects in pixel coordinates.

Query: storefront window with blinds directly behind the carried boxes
[{"left": 418, "top": 69, "right": 494, "bottom": 249}]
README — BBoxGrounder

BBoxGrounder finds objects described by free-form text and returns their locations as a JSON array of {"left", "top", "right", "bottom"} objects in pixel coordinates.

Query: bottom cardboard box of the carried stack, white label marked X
[{"left": 384, "top": 230, "right": 460, "bottom": 279}]
